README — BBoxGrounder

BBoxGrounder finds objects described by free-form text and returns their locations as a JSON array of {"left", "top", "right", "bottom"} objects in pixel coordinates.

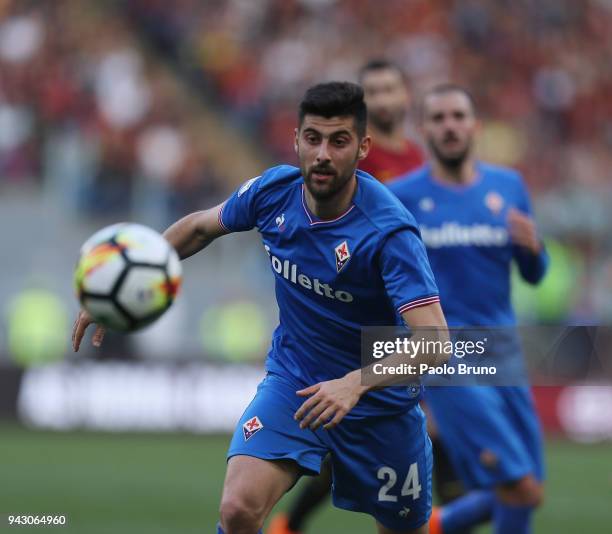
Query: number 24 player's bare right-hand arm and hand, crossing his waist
[{"left": 295, "top": 302, "right": 449, "bottom": 430}]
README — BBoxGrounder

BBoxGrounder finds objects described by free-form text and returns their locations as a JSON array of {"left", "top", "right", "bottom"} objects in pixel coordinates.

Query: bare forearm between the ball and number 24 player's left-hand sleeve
[{"left": 164, "top": 204, "right": 228, "bottom": 260}]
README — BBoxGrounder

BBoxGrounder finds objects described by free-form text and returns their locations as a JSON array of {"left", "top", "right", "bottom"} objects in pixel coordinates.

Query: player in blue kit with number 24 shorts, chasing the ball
[{"left": 73, "top": 82, "right": 447, "bottom": 534}]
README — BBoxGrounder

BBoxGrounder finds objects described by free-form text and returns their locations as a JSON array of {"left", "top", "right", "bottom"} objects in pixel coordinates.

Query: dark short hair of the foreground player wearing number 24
[{"left": 299, "top": 82, "right": 368, "bottom": 138}]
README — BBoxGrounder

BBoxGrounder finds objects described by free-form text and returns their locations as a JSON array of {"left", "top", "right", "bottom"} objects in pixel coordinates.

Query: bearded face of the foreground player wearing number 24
[{"left": 295, "top": 115, "right": 370, "bottom": 200}]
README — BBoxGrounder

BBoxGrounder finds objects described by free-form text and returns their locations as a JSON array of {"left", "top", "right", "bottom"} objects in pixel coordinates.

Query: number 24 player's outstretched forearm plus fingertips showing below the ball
[{"left": 72, "top": 204, "right": 228, "bottom": 352}]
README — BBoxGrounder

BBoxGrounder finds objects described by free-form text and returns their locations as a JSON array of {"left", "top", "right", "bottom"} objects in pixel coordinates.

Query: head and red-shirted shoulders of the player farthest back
[{"left": 359, "top": 59, "right": 424, "bottom": 183}]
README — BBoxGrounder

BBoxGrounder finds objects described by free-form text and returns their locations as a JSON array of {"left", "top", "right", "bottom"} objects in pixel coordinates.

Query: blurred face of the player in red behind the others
[{"left": 361, "top": 69, "right": 410, "bottom": 132}]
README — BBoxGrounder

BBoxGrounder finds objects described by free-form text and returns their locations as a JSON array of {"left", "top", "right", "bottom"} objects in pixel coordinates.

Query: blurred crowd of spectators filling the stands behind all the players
[{"left": 0, "top": 0, "right": 612, "bottom": 336}]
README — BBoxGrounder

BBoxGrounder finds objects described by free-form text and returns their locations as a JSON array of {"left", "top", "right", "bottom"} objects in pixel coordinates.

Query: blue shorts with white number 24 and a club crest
[{"left": 228, "top": 374, "right": 432, "bottom": 531}]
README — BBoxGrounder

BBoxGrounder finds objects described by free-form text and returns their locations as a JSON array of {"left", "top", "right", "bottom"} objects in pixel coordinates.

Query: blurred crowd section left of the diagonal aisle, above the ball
[{"left": 0, "top": 0, "right": 227, "bottom": 225}]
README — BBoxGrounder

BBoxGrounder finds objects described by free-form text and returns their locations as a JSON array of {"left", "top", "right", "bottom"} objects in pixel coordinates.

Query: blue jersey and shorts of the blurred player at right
[{"left": 389, "top": 163, "right": 548, "bottom": 487}]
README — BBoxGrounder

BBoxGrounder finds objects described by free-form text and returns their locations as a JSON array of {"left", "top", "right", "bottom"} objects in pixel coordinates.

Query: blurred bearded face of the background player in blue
[{"left": 422, "top": 91, "right": 478, "bottom": 167}]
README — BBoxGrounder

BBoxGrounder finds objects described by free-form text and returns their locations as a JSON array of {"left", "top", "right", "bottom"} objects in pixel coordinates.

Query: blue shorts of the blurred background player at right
[{"left": 425, "top": 386, "right": 544, "bottom": 488}]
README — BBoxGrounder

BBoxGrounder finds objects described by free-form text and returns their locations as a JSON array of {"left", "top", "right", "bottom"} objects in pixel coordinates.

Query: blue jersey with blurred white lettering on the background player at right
[{"left": 389, "top": 163, "right": 548, "bottom": 326}]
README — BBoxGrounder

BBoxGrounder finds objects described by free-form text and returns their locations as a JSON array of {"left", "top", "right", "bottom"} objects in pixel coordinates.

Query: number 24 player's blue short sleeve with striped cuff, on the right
[{"left": 379, "top": 228, "right": 440, "bottom": 315}]
